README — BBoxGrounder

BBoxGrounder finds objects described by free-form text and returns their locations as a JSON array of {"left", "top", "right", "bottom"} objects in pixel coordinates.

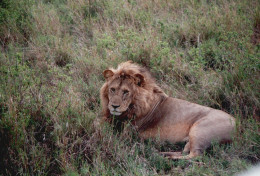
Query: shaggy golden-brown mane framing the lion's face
[{"left": 100, "top": 61, "right": 167, "bottom": 119}]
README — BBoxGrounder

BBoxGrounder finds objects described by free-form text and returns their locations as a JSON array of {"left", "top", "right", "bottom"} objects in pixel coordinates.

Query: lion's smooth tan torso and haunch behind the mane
[{"left": 140, "top": 97, "right": 234, "bottom": 151}]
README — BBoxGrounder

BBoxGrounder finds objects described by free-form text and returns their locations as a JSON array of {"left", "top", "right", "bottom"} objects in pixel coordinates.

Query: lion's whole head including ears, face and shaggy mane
[{"left": 100, "top": 61, "right": 165, "bottom": 121}]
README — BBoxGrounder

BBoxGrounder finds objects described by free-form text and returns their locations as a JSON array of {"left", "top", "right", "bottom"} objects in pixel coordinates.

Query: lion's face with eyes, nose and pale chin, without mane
[{"left": 108, "top": 78, "right": 134, "bottom": 116}]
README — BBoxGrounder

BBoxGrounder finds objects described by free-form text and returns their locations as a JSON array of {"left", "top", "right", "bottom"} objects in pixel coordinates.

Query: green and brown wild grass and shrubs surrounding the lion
[{"left": 0, "top": 0, "right": 260, "bottom": 175}]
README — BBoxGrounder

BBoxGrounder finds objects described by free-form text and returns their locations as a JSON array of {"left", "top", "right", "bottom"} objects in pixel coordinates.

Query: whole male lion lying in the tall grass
[{"left": 100, "top": 61, "right": 235, "bottom": 159}]
